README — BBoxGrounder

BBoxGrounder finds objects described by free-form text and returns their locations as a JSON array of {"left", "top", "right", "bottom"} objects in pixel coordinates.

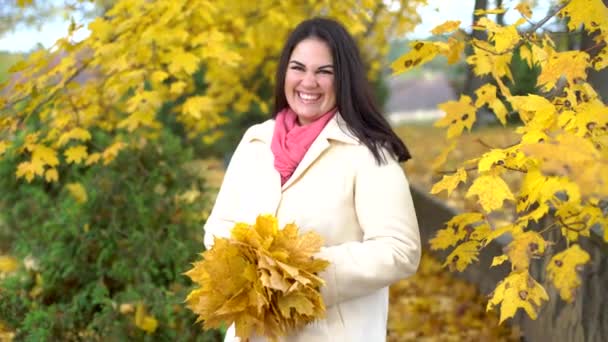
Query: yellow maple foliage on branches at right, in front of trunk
[{"left": 394, "top": 0, "right": 608, "bottom": 316}]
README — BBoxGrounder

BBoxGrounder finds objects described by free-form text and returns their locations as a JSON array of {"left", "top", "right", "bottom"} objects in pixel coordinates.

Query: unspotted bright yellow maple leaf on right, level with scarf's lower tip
[{"left": 466, "top": 174, "right": 515, "bottom": 212}]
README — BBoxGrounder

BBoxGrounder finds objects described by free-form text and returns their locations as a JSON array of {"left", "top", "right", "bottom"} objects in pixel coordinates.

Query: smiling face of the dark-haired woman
[{"left": 285, "top": 38, "right": 336, "bottom": 125}]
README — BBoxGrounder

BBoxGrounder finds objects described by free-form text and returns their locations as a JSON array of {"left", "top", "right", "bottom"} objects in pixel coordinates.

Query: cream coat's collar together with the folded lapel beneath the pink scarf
[{"left": 245, "top": 113, "right": 360, "bottom": 191}]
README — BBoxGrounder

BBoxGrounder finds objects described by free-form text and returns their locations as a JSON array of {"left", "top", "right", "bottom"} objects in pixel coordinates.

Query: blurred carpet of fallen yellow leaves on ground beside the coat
[{"left": 386, "top": 251, "right": 521, "bottom": 342}]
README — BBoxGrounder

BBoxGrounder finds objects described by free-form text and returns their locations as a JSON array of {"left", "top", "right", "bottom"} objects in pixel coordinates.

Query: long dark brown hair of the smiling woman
[{"left": 273, "top": 18, "right": 411, "bottom": 164}]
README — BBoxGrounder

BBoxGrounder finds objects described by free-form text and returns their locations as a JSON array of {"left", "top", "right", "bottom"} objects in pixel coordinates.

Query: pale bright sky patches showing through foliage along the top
[{"left": 0, "top": 0, "right": 550, "bottom": 52}]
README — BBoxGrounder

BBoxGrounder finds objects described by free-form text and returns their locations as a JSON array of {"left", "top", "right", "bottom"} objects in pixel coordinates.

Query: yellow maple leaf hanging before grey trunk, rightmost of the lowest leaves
[{"left": 547, "top": 244, "right": 590, "bottom": 302}]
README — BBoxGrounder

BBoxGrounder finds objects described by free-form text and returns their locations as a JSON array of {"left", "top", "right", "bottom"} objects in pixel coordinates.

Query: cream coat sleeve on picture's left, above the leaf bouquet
[{"left": 204, "top": 133, "right": 247, "bottom": 249}]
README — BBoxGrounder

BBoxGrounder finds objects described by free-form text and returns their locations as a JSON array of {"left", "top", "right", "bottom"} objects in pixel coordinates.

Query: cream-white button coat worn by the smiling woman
[{"left": 205, "top": 113, "right": 421, "bottom": 342}]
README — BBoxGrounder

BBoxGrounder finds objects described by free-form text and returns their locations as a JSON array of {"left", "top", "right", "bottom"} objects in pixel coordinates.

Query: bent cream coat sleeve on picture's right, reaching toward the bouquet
[{"left": 317, "top": 154, "right": 421, "bottom": 306}]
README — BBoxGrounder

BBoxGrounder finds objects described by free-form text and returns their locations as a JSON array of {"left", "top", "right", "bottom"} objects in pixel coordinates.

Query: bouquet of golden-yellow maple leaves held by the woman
[{"left": 186, "top": 215, "right": 329, "bottom": 340}]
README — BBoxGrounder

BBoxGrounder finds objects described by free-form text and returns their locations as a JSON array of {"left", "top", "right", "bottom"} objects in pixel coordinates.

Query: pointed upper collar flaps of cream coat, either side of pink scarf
[{"left": 246, "top": 112, "right": 360, "bottom": 145}]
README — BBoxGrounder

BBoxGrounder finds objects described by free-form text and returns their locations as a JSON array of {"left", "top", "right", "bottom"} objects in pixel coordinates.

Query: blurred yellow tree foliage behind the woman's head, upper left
[{"left": 0, "top": 0, "right": 424, "bottom": 181}]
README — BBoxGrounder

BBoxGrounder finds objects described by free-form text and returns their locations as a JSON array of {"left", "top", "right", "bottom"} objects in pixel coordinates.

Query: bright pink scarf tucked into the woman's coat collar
[{"left": 270, "top": 108, "right": 336, "bottom": 185}]
